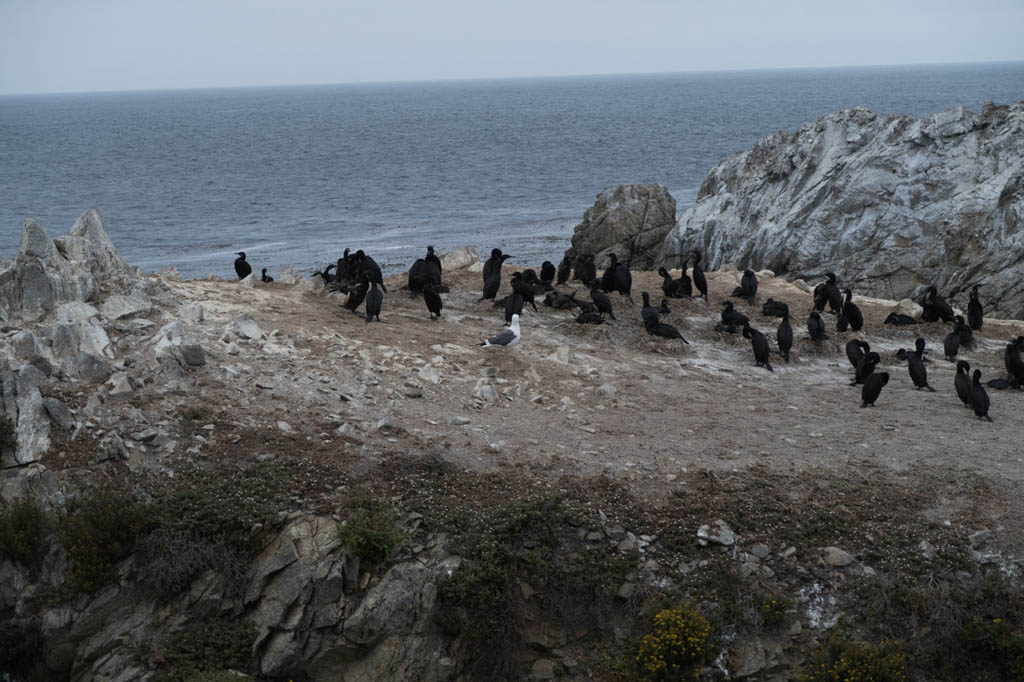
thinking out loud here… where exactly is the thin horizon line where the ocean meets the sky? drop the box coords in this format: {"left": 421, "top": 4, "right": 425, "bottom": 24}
{"left": 0, "top": 58, "right": 1024, "bottom": 98}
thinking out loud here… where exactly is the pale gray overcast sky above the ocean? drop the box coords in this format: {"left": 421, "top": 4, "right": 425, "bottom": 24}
{"left": 0, "top": 0, "right": 1024, "bottom": 93}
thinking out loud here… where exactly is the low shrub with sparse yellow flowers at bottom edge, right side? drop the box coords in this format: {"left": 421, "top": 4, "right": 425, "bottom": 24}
{"left": 797, "top": 635, "right": 906, "bottom": 682}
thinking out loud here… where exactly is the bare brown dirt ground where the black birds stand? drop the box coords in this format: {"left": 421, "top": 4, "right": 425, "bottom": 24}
{"left": 48, "top": 258, "right": 1024, "bottom": 557}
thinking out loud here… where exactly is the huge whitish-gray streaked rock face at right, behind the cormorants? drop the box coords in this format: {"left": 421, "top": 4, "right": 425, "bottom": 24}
{"left": 657, "top": 102, "right": 1024, "bottom": 316}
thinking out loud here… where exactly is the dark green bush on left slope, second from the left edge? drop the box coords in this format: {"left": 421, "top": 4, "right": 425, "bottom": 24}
{"left": 57, "top": 489, "right": 153, "bottom": 594}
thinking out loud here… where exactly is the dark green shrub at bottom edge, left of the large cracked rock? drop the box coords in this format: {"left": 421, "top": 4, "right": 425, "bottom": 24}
{"left": 155, "top": 621, "right": 256, "bottom": 682}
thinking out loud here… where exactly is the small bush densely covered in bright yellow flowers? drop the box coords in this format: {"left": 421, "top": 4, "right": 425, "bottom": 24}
{"left": 636, "top": 606, "right": 711, "bottom": 682}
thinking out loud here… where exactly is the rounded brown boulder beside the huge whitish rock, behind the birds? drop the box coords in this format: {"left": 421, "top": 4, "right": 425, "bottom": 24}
{"left": 565, "top": 184, "right": 676, "bottom": 269}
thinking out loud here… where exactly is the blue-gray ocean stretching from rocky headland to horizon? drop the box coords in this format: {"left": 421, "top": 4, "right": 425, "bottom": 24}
{"left": 0, "top": 62, "right": 1024, "bottom": 278}
